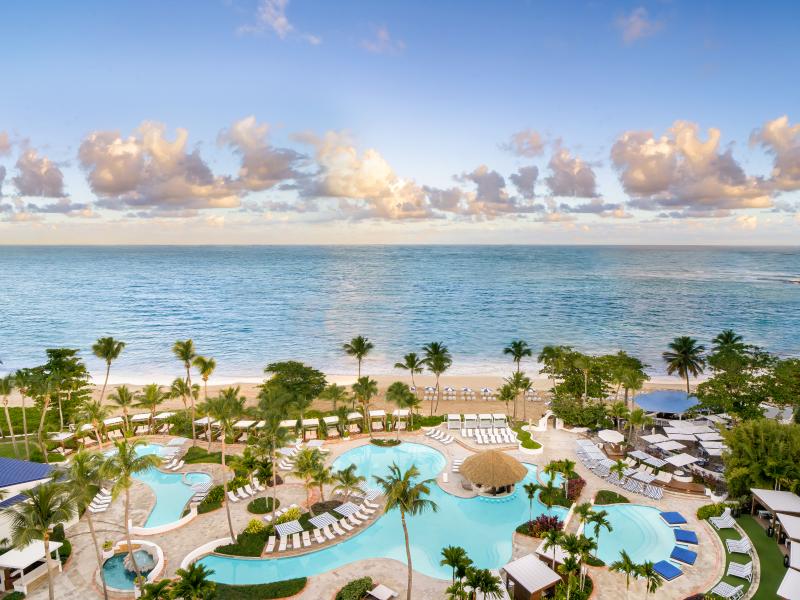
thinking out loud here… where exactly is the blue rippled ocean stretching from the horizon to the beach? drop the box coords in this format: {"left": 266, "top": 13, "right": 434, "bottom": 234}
{"left": 0, "top": 246, "right": 800, "bottom": 382}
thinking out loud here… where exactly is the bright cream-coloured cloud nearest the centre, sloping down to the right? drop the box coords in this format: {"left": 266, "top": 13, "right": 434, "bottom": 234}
{"left": 298, "top": 131, "right": 432, "bottom": 219}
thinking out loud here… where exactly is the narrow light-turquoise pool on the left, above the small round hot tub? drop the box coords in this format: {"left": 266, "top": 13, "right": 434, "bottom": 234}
{"left": 119, "top": 444, "right": 211, "bottom": 528}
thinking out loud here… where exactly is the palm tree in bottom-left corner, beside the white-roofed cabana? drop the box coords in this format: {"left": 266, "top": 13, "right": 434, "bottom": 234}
{"left": 6, "top": 482, "right": 75, "bottom": 600}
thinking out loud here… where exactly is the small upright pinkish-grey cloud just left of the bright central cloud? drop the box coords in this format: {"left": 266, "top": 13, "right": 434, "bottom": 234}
{"left": 218, "top": 116, "right": 307, "bottom": 191}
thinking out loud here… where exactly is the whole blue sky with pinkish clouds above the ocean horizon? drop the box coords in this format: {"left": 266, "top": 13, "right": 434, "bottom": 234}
{"left": 0, "top": 0, "right": 800, "bottom": 245}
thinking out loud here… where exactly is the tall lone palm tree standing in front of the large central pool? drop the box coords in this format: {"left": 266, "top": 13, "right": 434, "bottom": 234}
{"left": 375, "top": 463, "right": 439, "bottom": 600}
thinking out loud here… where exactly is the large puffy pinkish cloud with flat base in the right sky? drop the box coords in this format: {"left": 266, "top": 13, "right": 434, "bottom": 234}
{"left": 611, "top": 121, "right": 772, "bottom": 212}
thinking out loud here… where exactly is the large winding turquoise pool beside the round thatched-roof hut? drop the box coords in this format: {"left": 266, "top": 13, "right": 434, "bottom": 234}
{"left": 199, "top": 443, "right": 567, "bottom": 585}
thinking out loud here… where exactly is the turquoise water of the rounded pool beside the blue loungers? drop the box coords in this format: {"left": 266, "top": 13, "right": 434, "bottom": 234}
{"left": 585, "top": 504, "right": 675, "bottom": 564}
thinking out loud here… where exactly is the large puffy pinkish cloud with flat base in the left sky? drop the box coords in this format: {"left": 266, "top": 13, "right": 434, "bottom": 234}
{"left": 78, "top": 121, "right": 239, "bottom": 210}
